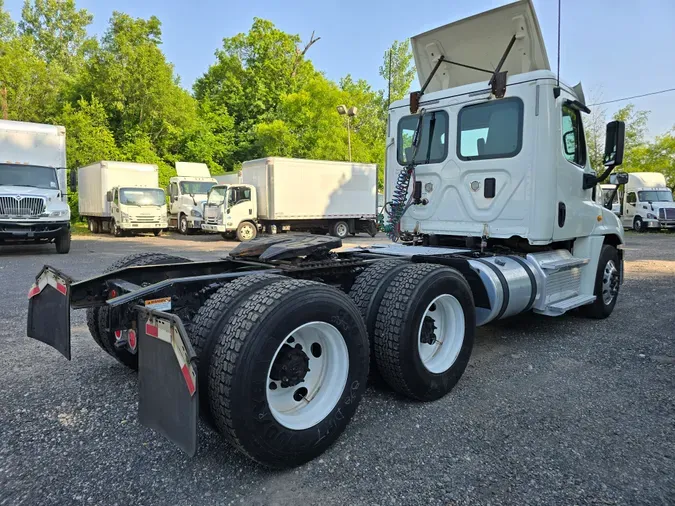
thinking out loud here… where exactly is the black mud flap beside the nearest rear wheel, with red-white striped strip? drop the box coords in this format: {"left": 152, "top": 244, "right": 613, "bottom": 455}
{"left": 137, "top": 306, "right": 199, "bottom": 457}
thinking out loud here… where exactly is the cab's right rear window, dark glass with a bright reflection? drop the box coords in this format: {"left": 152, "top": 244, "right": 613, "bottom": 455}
{"left": 457, "top": 98, "right": 523, "bottom": 160}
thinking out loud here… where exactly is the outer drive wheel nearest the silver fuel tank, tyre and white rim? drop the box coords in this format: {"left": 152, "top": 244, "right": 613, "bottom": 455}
{"left": 374, "top": 264, "right": 476, "bottom": 401}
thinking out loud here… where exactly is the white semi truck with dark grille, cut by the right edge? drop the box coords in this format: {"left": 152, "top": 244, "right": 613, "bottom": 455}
{"left": 621, "top": 172, "right": 675, "bottom": 232}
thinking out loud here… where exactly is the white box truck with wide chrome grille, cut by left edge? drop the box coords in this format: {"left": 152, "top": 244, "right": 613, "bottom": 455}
{"left": 0, "top": 120, "right": 70, "bottom": 253}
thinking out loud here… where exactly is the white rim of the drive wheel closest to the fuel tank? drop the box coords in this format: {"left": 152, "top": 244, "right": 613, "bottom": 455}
{"left": 417, "top": 294, "right": 466, "bottom": 374}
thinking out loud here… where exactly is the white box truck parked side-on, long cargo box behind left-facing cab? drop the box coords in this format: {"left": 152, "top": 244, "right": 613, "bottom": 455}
{"left": 202, "top": 157, "right": 377, "bottom": 241}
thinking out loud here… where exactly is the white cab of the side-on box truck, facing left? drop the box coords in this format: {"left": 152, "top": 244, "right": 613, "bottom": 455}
{"left": 202, "top": 184, "right": 258, "bottom": 241}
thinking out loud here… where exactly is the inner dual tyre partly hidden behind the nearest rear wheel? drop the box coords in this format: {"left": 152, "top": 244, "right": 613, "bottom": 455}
{"left": 190, "top": 274, "right": 288, "bottom": 427}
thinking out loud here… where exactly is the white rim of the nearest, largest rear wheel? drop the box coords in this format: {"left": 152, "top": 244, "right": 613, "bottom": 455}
{"left": 266, "top": 321, "right": 349, "bottom": 430}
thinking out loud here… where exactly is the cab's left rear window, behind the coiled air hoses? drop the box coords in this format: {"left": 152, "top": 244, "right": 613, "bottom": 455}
{"left": 396, "top": 111, "right": 448, "bottom": 165}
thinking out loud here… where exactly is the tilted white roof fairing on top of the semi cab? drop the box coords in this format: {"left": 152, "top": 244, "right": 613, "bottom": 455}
{"left": 411, "top": 0, "right": 550, "bottom": 92}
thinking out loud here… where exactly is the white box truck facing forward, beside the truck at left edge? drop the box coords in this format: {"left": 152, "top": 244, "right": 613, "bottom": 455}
{"left": 77, "top": 161, "right": 168, "bottom": 237}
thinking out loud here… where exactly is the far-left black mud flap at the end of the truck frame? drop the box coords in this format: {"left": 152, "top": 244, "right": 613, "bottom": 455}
{"left": 26, "top": 265, "right": 73, "bottom": 360}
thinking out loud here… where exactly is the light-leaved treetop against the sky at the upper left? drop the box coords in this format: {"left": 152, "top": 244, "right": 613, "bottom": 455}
{"left": 19, "top": 0, "right": 94, "bottom": 73}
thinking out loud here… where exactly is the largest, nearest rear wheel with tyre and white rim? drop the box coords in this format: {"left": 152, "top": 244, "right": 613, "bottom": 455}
{"left": 209, "top": 279, "right": 368, "bottom": 468}
